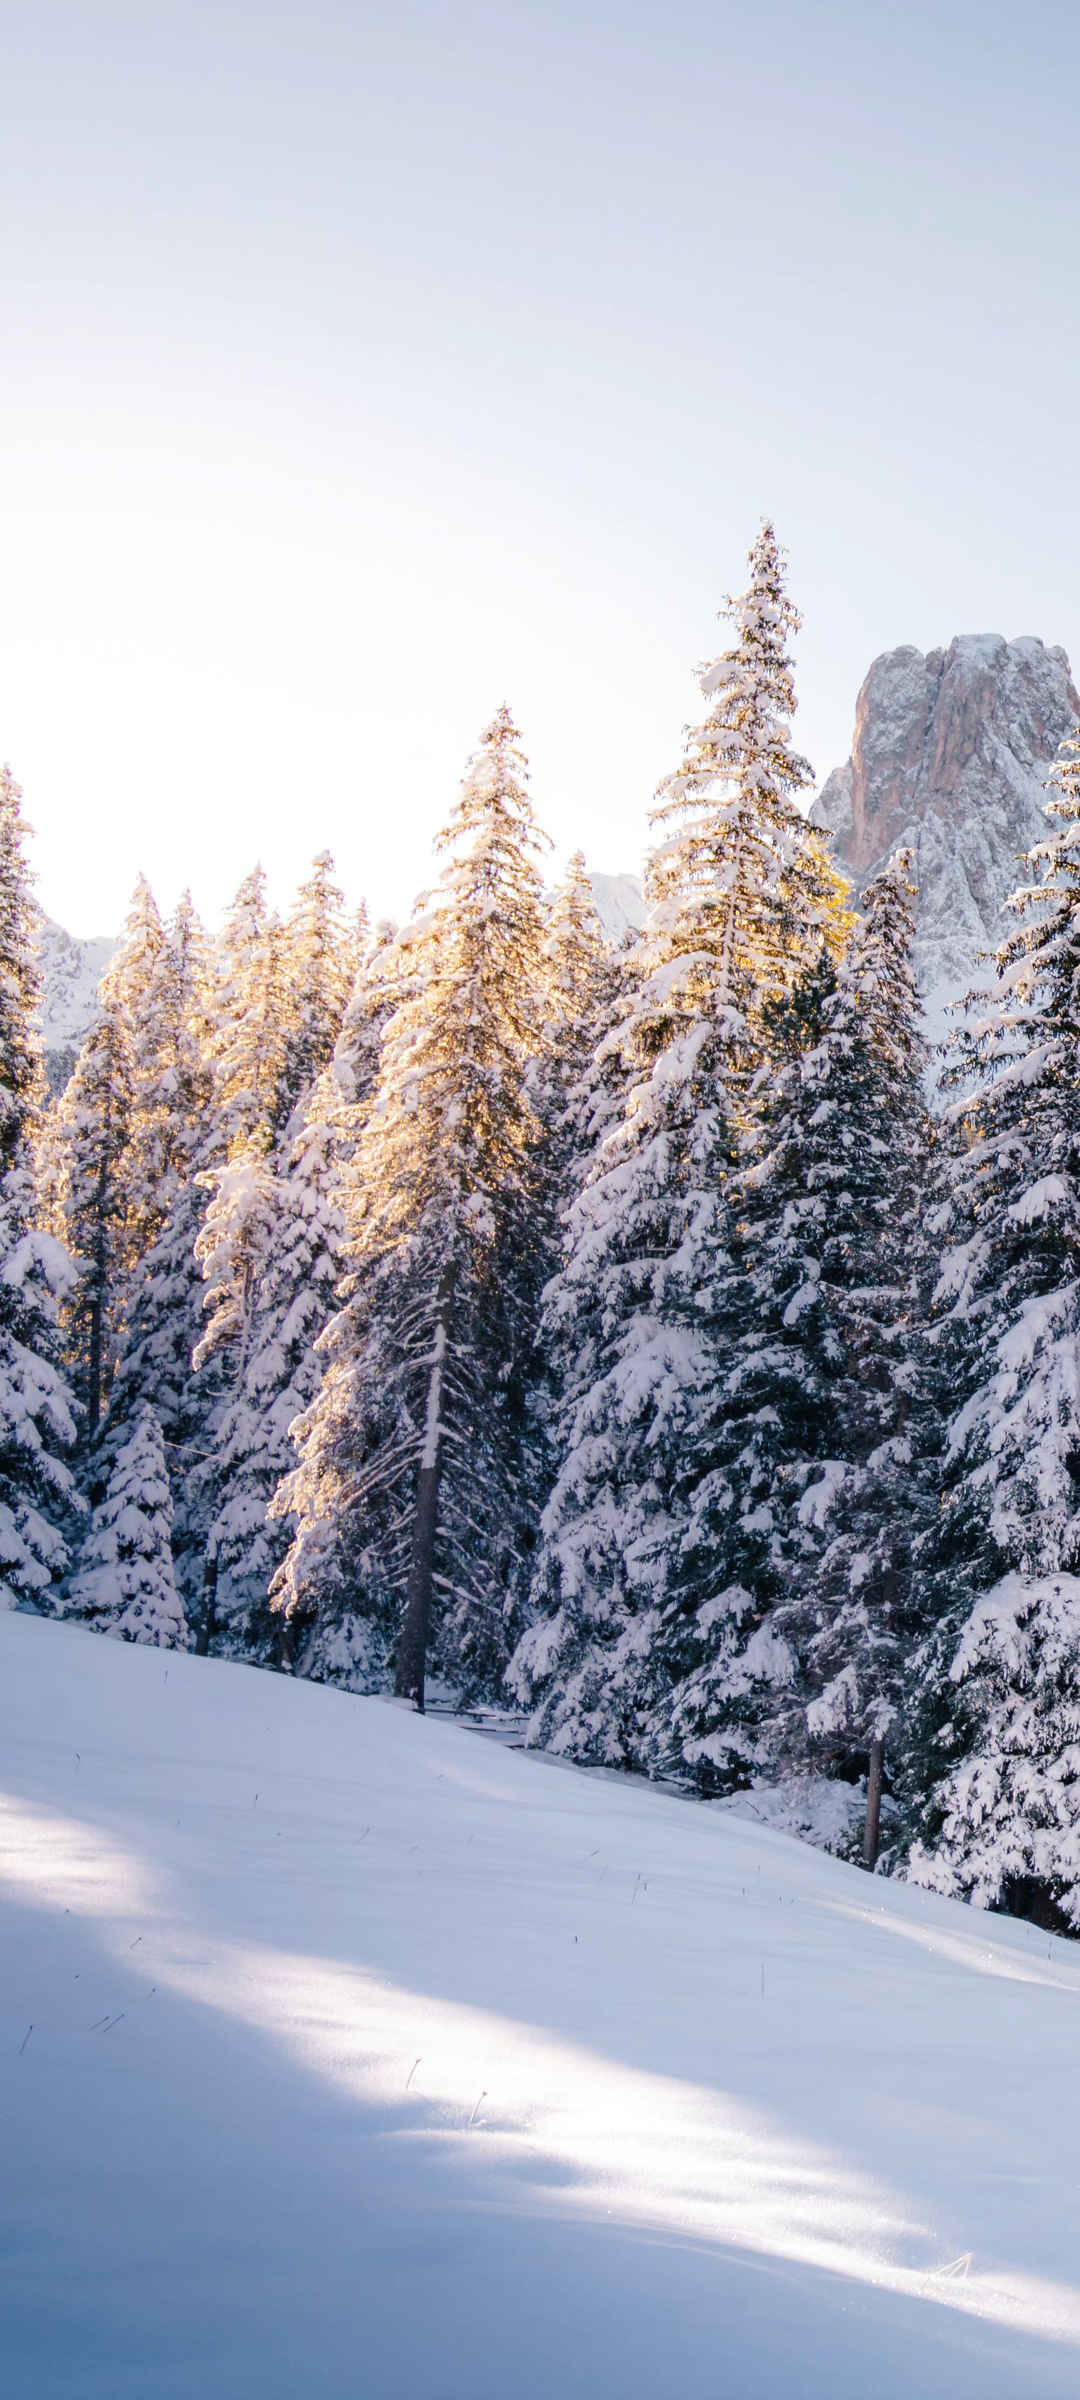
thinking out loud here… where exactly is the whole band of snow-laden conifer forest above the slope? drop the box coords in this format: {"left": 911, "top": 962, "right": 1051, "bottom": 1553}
{"left": 0, "top": 523, "right": 1080, "bottom": 1932}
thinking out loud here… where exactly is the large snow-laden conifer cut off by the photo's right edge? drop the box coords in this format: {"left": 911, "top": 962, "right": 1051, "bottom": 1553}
{"left": 907, "top": 734, "right": 1080, "bottom": 1930}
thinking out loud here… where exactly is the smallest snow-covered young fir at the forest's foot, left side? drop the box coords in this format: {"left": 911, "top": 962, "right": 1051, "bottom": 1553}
{"left": 67, "top": 1406, "right": 187, "bottom": 1649}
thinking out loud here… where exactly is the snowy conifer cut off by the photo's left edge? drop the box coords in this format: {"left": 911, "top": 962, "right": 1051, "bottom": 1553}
{"left": 0, "top": 766, "right": 79, "bottom": 1608}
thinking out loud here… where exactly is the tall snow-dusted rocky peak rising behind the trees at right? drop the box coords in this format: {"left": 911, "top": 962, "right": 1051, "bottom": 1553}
{"left": 814, "top": 634, "right": 1080, "bottom": 1030}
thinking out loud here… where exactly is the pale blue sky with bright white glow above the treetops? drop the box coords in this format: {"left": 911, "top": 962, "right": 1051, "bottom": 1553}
{"left": 0, "top": 0, "right": 1080, "bottom": 934}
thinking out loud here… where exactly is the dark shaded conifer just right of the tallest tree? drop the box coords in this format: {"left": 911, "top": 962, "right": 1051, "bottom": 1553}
{"left": 674, "top": 854, "right": 929, "bottom": 1833}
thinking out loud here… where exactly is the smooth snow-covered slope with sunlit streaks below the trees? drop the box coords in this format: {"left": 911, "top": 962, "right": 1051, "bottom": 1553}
{"left": 0, "top": 1615, "right": 1080, "bottom": 2400}
